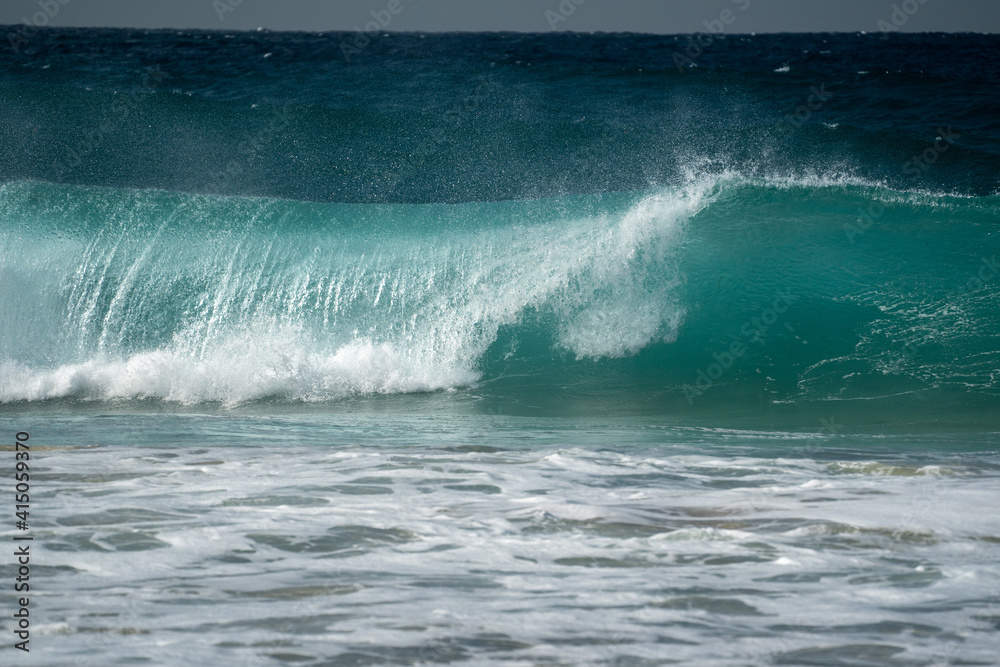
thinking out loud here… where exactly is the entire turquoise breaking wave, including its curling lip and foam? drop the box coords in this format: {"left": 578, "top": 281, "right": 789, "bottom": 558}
{"left": 0, "top": 176, "right": 1000, "bottom": 420}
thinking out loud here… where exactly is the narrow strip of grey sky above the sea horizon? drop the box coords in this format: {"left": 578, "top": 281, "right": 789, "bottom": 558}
{"left": 0, "top": 0, "right": 1000, "bottom": 34}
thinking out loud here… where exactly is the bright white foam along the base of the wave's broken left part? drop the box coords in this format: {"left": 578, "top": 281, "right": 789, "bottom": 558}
{"left": 0, "top": 332, "right": 475, "bottom": 405}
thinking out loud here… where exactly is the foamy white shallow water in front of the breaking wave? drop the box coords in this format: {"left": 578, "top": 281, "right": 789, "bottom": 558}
{"left": 0, "top": 410, "right": 1000, "bottom": 665}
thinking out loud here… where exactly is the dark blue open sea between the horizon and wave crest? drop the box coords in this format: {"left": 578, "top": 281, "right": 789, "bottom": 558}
{"left": 0, "top": 30, "right": 1000, "bottom": 203}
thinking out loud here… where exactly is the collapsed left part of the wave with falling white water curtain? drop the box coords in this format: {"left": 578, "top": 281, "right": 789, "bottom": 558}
{"left": 0, "top": 184, "right": 703, "bottom": 403}
